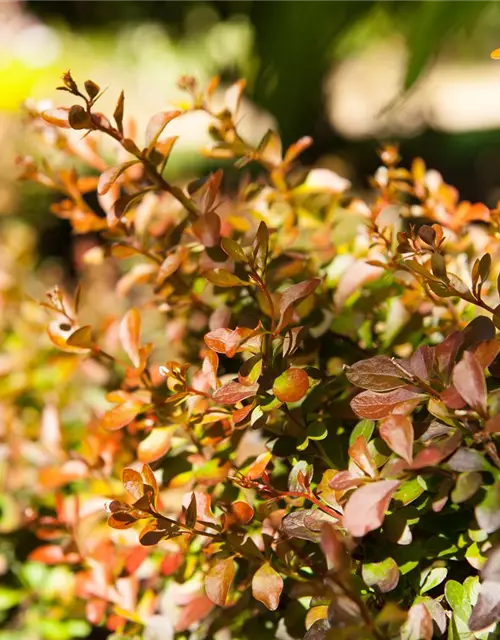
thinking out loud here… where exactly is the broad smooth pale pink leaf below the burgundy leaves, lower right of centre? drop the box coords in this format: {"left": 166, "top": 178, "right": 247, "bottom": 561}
{"left": 344, "top": 480, "right": 400, "bottom": 538}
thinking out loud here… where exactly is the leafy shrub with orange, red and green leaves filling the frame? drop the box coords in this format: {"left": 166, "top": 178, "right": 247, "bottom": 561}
{"left": 10, "top": 73, "right": 500, "bottom": 640}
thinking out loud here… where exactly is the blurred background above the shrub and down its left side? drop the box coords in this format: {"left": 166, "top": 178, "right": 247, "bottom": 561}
{"left": 0, "top": 0, "right": 500, "bottom": 640}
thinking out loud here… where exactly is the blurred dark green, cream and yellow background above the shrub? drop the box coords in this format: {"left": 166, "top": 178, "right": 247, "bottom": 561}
{"left": 4, "top": 0, "right": 500, "bottom": 226}
